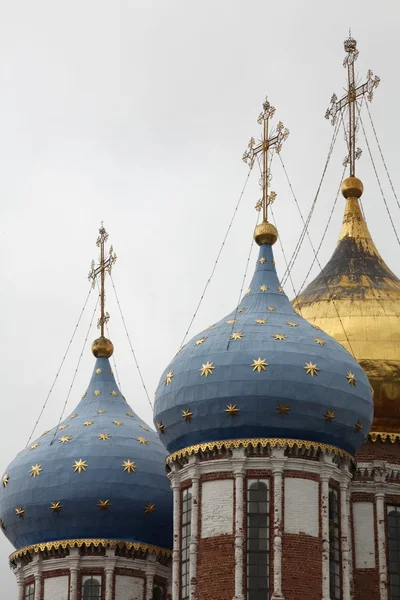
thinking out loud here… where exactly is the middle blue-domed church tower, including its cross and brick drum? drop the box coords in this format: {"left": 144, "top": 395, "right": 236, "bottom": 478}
{"left": 154, "top": 100, "right": 373, "bottom": 600}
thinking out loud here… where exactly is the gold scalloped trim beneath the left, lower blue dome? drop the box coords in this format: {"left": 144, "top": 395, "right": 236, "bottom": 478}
{"left": 9, "top": 538, "right": 172, "bottom": 560}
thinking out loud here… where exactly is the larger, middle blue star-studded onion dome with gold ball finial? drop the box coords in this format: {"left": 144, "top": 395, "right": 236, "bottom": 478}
{"left": 154, "top": 227, "right": 373, "bottom": 454}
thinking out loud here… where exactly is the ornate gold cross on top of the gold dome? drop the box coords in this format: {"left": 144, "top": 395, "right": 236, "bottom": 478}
{"left": 325, "top": 35, "right": 380, "bottom": 177}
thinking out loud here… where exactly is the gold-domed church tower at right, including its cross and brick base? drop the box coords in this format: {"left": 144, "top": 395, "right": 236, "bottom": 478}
{"left": 294, "top": 38, "right": 400, "bottom": 600}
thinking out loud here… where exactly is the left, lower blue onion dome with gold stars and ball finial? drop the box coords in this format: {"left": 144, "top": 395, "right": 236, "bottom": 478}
{"left": 0, "top": 340, "right": 172, "bottom": 549}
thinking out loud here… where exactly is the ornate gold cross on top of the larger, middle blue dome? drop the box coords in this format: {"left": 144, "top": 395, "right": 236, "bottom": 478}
{"left": 243, "top": 98, "right": 289, "bottom": 221}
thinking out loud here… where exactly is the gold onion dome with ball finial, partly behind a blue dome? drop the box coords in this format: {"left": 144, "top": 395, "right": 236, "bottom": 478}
{"left": 293, "top": 177, "right": 400, "bottom": 433}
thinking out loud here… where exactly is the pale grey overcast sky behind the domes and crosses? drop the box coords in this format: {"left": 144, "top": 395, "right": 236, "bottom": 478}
{"left": 0, "top": 0, "right": 400, "bottom": 600}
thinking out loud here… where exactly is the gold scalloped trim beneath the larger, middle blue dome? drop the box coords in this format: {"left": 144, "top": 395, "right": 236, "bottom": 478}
{"left": 165, "top": 438, "right": 354, "bottom": 464}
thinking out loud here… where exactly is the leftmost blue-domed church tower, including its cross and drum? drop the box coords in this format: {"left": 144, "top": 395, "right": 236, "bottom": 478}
{"left": 0, "top": 226, "right": 172, "bottom": 600}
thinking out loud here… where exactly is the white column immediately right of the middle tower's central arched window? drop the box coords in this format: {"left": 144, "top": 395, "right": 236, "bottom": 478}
{"left": 271, "top": 448, "right": 286, "bottom": 600}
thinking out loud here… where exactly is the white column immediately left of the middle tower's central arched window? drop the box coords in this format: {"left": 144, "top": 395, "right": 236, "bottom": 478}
{"left": 232, "top": 448, "right": 245, "bottom": 600}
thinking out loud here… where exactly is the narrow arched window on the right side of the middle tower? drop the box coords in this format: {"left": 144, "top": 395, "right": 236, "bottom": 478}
{"left": 329, "top": 487, "right": 342, "bottom": 600}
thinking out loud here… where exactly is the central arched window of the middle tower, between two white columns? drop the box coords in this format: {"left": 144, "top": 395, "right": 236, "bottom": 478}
{"left": 247, "top": 479, "right": 269, "bottom": 600}
